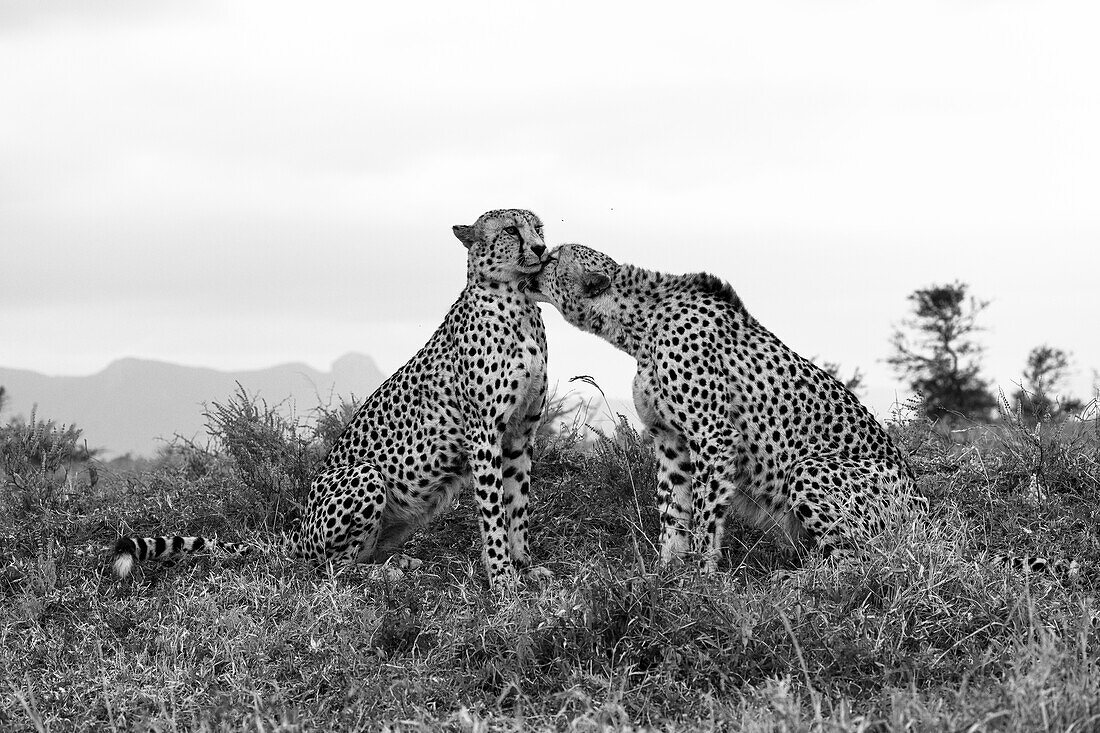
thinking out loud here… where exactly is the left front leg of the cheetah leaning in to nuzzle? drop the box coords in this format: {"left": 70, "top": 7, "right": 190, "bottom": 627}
{"left": 650, "top": 428, "right": 693, "bottom": 565}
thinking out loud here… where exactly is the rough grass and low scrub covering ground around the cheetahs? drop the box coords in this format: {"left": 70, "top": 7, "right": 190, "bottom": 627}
{"left": 0, "top": 393, "right": 1100, "bottom": 731}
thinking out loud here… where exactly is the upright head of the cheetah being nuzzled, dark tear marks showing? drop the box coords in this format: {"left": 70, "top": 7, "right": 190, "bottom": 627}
{"left": 452, "top": 209, "right": 550, "bottom": 283}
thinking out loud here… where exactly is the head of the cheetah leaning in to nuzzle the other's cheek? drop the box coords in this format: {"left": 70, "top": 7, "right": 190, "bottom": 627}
{"left": 526, "top": 244, "right": 620, "bottom": 336}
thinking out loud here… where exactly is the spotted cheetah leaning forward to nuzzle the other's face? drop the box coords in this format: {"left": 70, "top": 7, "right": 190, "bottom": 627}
{"left": 526, "top": 244, "right": 1073, "bottom": 572}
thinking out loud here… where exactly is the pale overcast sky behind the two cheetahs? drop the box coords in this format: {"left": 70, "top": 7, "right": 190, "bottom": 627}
{"left": 0, "top": 0, "right": 1100, "bottom": 412}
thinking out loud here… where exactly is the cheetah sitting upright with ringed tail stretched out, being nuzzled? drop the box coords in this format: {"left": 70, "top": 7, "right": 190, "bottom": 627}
{"left": 113, "top": 209, "right": 549, "bottom": 586}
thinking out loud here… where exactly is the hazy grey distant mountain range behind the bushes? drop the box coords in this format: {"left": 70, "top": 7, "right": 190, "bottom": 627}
{"left": 0, "top": 353, "right": 384, "bottom": 457}
